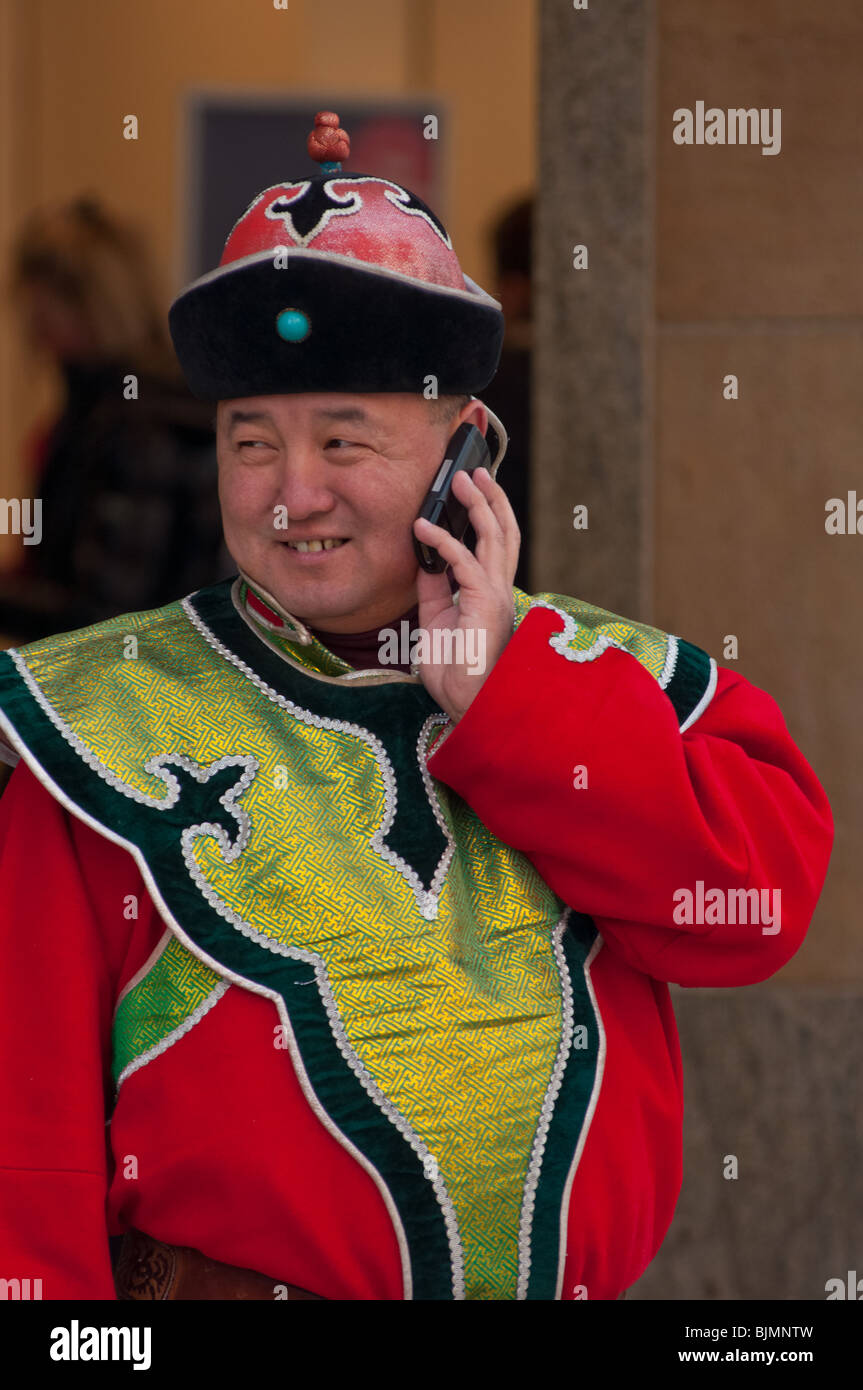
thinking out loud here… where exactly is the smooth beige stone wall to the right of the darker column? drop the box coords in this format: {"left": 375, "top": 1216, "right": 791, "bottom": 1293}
{"left": 653, "top": 0, "right": 863, "bottom": 984}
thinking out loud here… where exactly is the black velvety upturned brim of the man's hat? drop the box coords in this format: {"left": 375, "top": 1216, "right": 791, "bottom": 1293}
{"left": 168, "top": 249, "right": 504, "bottom": 402}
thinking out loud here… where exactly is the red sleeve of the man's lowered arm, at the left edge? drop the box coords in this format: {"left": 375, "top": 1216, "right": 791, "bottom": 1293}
{"left": 0, "top": 762, "right": 159, "bottom": 1300}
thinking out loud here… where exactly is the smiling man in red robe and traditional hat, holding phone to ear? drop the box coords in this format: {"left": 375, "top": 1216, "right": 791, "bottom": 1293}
{"left": 0, "top": 114, "right": 832, "bottom": 1300}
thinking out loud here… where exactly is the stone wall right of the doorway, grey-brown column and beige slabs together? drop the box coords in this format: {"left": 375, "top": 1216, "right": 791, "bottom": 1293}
{"left": 532, "top": 0, "right": 863, "bottom": 987}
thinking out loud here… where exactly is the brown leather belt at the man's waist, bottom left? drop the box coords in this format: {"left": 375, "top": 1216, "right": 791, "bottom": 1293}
{"left": 114, "top": 1230, "right": 325, "bottom": 1302}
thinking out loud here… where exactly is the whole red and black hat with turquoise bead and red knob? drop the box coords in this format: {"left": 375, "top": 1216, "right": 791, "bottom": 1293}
{"left": 168, "top": 111, "right": 504, "bottom": 400}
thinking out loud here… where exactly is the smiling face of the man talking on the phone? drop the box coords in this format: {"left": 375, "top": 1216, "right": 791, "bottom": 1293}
{"left": 217, "top": 392, "right": 488, "bottom": 632}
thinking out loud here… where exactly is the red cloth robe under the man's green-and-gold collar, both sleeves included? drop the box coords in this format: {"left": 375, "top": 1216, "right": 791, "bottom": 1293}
{"left": 0, "top": 609, "right": 832, "bottom": 1300}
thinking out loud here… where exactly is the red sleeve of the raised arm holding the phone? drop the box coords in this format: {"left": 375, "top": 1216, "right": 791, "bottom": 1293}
{"left": 428, "top": 609, "right": 832, "bottom": 986}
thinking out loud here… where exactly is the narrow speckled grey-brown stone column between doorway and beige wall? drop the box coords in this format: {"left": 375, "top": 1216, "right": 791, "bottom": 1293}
{"left": 531, "top": 0, "right": 655, "bottom": 620}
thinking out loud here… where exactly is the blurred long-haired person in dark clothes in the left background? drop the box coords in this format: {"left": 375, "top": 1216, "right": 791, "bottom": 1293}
{"left": 0, "top": 197, "right": 233, "bottom": 642}
